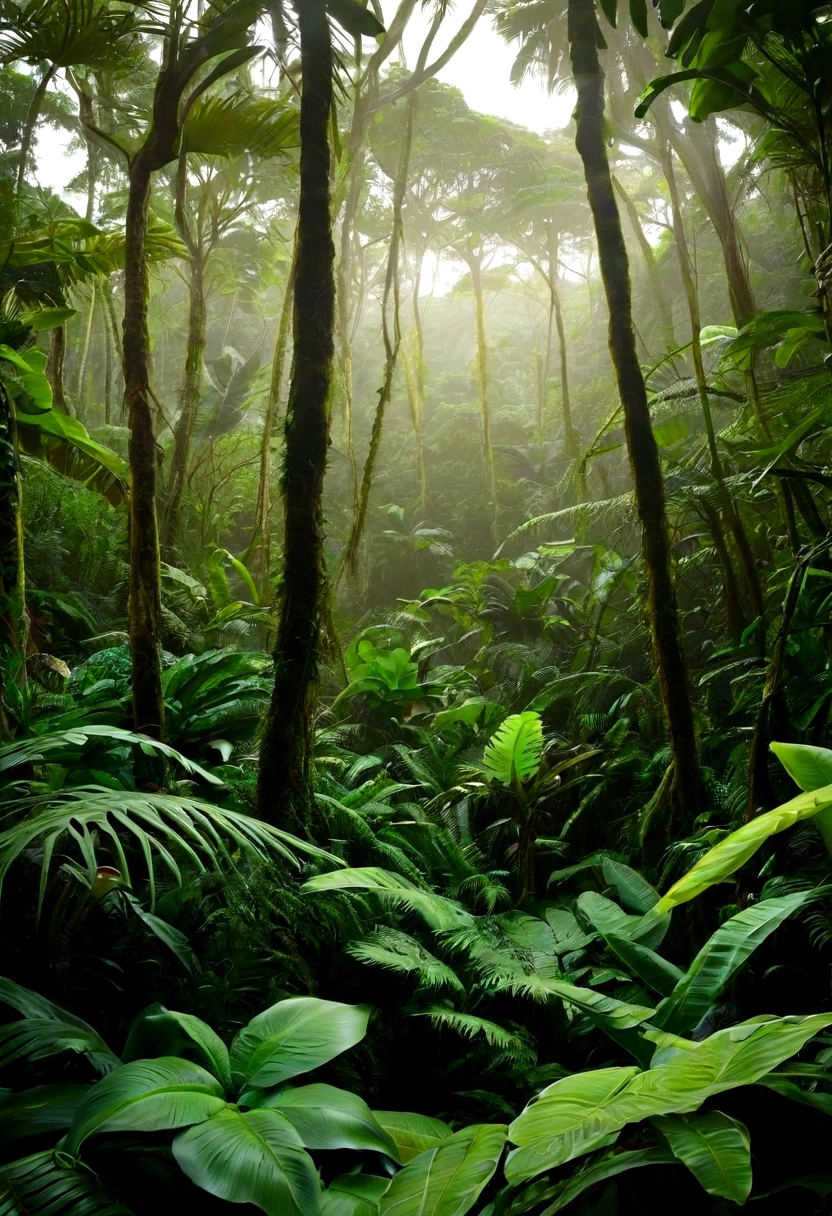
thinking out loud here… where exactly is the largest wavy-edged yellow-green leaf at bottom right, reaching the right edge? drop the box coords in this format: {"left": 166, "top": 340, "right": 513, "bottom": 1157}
{"left": 506, "top": 1014, "right": 832, "bottom": 1183}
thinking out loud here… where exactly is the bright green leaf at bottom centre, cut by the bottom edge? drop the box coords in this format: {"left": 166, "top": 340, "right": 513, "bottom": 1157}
{"left": 378, "top": 1124, "right": 506, "bottom": 1216}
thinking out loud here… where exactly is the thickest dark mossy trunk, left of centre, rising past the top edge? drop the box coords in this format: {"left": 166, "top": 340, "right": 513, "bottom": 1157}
{"left": 258, "top": 0, "right": 335, "bottom": 828}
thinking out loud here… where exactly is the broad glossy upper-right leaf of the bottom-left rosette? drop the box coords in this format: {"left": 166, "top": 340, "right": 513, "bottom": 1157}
{"left": 231, "top": 996, "right": 370, "bottom": 1086}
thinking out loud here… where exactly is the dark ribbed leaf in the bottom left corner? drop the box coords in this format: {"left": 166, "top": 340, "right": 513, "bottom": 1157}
{"left": 0, "top": 1153, "right": 134, "bottom": 1216}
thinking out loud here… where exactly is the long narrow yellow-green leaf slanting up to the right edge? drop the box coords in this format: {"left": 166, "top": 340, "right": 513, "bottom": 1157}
{"left": 651, "top": 784, "right": 832, "bottom": 916}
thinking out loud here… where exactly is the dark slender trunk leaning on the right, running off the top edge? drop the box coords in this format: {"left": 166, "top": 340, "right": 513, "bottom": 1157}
{"left": 568, "top": 0, "right": 702, "bottom": 828}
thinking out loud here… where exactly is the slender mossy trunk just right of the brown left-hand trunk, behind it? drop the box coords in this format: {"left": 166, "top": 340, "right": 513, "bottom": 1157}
{"left": 162, "top": 250, "right": 207, "bottom": 557}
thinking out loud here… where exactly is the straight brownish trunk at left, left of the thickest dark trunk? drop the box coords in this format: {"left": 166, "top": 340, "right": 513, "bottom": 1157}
{"left": 123, "top": 148, "right": 164, "bottom": 738}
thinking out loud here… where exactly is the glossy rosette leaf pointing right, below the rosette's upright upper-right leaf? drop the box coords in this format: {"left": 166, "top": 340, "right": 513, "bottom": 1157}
{"left": 248, "top": 1085, "right": 399, "bottom": 1161}
